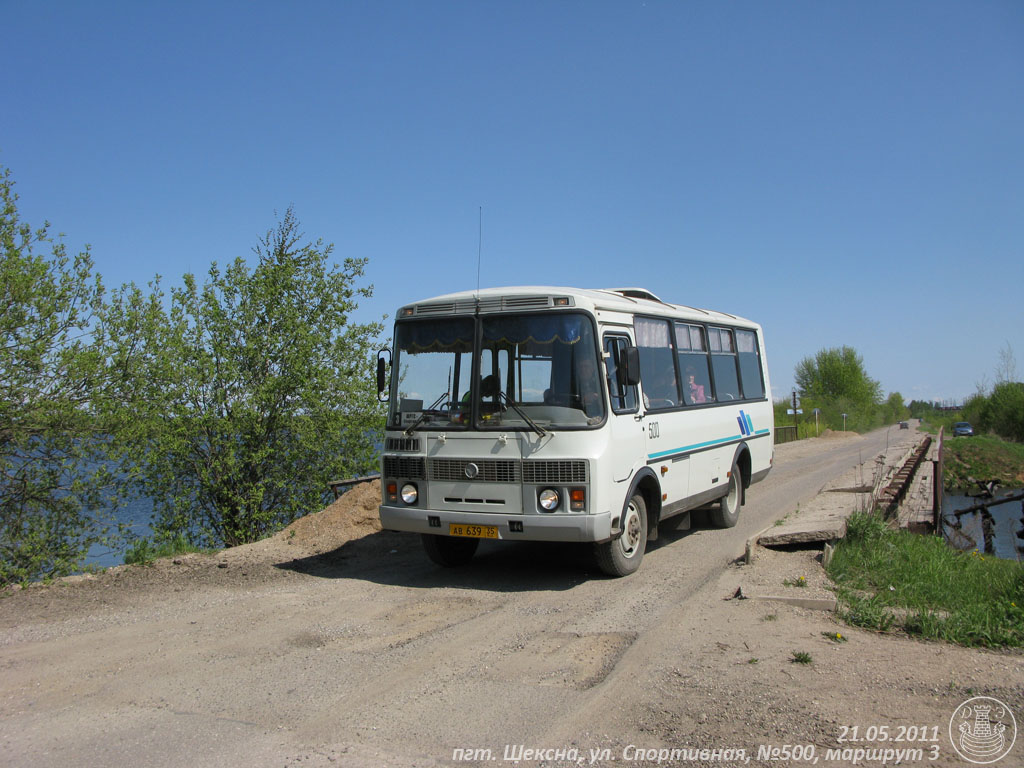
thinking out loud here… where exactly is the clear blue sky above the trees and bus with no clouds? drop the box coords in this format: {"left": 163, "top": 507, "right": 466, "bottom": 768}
{"left": 0, "top": 0, "right": 1024, "bottom": 400}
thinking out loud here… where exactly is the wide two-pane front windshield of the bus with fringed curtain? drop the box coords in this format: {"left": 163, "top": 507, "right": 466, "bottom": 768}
{"left": 389, "top": 312, "right": 605, "bottom": 429}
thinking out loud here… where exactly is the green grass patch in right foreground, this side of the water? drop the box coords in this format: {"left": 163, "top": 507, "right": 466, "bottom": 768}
{"left": 828, "top": 513, "right": 1024, "bottom": 647}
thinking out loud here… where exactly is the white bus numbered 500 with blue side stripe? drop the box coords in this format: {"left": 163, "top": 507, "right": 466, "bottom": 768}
{"left": 377, "top": 287, "right": 774, "bottom": 575}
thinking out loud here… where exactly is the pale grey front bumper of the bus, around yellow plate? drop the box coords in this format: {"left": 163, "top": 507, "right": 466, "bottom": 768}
{"left": 380, "top": 504, "right": 612, "bottom": 542}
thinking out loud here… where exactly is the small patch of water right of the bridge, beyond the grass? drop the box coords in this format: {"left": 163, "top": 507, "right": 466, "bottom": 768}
{"left": 942, "top": 488, "right": 1024, "bottom": 560}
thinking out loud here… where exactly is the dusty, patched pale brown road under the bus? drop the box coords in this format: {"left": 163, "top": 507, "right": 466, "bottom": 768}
{"left": 0, "top": 430, "right": 1024, "bottom": 768}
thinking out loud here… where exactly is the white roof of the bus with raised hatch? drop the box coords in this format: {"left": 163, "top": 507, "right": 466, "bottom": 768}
{"left": 397, "top": 286, "right": 758, "bottom": 328}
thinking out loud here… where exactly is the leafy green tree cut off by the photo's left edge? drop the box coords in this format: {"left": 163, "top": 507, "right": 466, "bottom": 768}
{"left": 0, "top": 163, "right": 121, "bottom": 585}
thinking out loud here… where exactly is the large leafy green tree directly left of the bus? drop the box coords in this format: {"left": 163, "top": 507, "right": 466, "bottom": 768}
{"left": 119, "top": 209, "right": 383, "bottom": 546}
